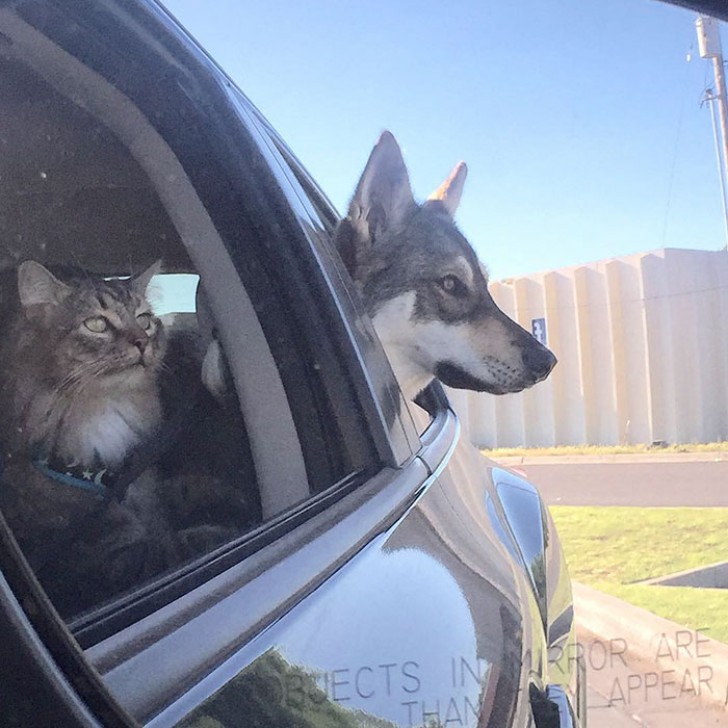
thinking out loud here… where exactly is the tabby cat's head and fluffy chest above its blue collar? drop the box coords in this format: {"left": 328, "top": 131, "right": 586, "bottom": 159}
{"left": 0, "top": 261, "right": 165, "bottom": 468}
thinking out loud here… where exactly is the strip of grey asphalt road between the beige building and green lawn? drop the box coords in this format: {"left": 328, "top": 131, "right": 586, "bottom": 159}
{"left": 515, "top": 460, "right": 728, "bottom": 507}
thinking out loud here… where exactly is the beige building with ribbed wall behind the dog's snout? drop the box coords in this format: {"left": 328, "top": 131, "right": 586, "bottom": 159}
{"left": 451, "top": 249, "right": 728, "bottom": 447}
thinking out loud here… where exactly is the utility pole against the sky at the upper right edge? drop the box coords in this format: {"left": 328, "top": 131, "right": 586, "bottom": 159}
{"left": 695, "top": 15, "right": 728, "bottom": 250}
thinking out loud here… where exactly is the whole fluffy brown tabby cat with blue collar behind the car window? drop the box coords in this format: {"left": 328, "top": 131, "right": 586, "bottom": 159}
{"left": 0, "top": 261, "right": 174, "bottom": 613}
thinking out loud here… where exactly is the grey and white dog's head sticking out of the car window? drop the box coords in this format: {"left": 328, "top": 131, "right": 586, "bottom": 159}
{"left": 334, "top": 132, "right": 556, "bottom": 400}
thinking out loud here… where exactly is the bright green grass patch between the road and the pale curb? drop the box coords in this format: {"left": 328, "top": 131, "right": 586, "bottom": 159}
{"left": 550, "top": 506, "right": 728, "bottom": 643}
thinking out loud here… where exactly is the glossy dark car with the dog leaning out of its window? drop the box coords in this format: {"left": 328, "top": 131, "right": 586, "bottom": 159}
{"left": 0, "top": 0, "right": 586, "bottom": 728}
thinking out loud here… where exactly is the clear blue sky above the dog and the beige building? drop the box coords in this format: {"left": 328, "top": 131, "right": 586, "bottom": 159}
{"left": 165, "top": 0, "right": 728, "bottom": 279}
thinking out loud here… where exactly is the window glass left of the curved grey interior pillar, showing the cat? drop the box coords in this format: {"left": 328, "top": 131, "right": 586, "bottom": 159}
{"left": 0, "top": 63, "right": 263, "bottom": 617}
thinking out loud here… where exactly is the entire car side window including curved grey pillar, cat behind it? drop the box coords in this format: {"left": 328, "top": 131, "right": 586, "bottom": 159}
{"left": 0, "top": 16, "right": 383, "bottom": 633}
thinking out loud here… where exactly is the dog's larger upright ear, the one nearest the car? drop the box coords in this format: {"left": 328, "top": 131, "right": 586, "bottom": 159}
{"left": 336, "top": 131, "right": 415, "bottom": 279}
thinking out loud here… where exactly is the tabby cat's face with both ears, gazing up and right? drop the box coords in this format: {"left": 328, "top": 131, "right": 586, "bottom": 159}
{"left": 18, "top": 261, "right": 165, "bottom": 386}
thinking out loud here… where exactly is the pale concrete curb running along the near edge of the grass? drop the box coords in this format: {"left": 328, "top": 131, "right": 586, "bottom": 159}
{"left": 572, "top": 582, "right": 728, "bottom": 710}
